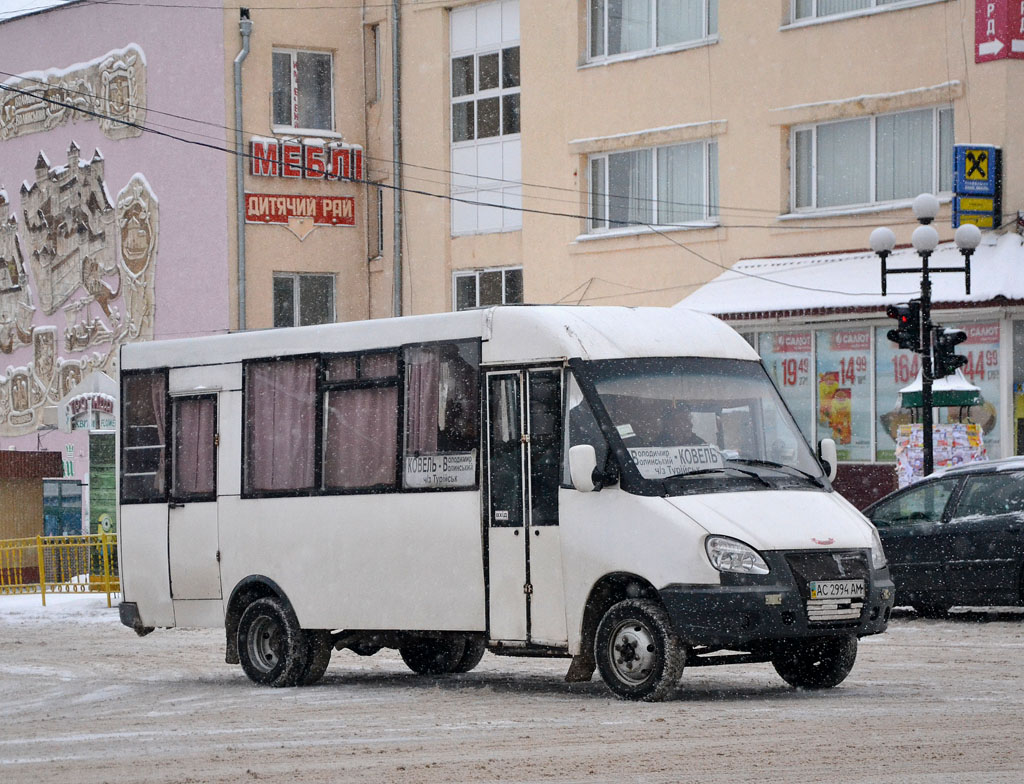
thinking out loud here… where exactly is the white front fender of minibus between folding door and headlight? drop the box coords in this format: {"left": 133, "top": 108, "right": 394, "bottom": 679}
{"left": 558, "top": 488, "right": 721, "bottom": 654}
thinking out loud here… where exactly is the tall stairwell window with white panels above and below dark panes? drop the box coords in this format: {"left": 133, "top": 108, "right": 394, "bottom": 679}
{"left": 451, "top": 0, "right": 522, "bottom": 234}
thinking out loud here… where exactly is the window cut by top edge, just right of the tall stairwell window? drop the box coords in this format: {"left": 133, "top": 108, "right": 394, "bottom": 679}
{"left": 590, "top": 0, "right": 718, "bottom": 59}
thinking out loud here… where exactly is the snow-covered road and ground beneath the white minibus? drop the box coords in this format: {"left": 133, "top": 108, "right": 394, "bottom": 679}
{"left": 0, "top": 595, "right": 1024, "bottom": 784}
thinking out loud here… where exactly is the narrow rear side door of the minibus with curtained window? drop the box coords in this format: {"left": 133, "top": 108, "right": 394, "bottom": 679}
{"left": 167, "top": 394, "right": 221, "bottom": 600}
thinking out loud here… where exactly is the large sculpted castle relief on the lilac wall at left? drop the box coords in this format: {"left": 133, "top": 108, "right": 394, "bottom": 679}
{"left": 0, "top": 145, "right": 160, "bottom": 436}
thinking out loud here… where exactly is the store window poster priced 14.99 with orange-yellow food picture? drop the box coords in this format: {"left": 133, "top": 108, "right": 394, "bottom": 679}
{"left": 815, "top": 329, "right": 872, "bottom": 461}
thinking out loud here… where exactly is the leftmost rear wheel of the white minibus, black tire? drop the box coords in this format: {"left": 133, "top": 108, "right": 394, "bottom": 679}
{"left": 236, "top": 597, "right": 308, "bottom": 686}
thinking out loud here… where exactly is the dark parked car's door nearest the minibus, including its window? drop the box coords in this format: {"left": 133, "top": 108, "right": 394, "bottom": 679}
{"left": 868, "top": 477, "right": 961, "bottom": 603}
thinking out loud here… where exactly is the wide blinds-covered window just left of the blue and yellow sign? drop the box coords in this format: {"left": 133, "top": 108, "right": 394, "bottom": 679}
{"left": 791, "top": 106, "right": 953, "bottom": 210}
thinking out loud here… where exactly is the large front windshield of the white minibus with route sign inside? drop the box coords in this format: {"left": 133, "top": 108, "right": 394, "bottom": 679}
{"left": 586, "top": 357, "right": 824, "bottom": 487}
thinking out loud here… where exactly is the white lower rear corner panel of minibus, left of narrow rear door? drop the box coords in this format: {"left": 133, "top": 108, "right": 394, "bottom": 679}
{"left": 118, "top": 504, "right": 174, "bottom": 626}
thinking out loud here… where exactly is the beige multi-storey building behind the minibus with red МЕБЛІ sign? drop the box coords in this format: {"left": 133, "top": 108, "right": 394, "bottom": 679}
{"left": 225, "top": 0, "right": 1024, "bottom": 503}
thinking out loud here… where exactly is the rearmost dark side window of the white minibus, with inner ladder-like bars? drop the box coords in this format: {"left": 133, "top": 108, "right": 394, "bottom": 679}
{"left": 121, "top": 371, "right": 167, "bottom": 503}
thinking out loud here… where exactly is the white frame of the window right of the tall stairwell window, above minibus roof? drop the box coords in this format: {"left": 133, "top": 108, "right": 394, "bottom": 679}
{"left": 587, "top": 139, "right": 720, "bottom": 234}
